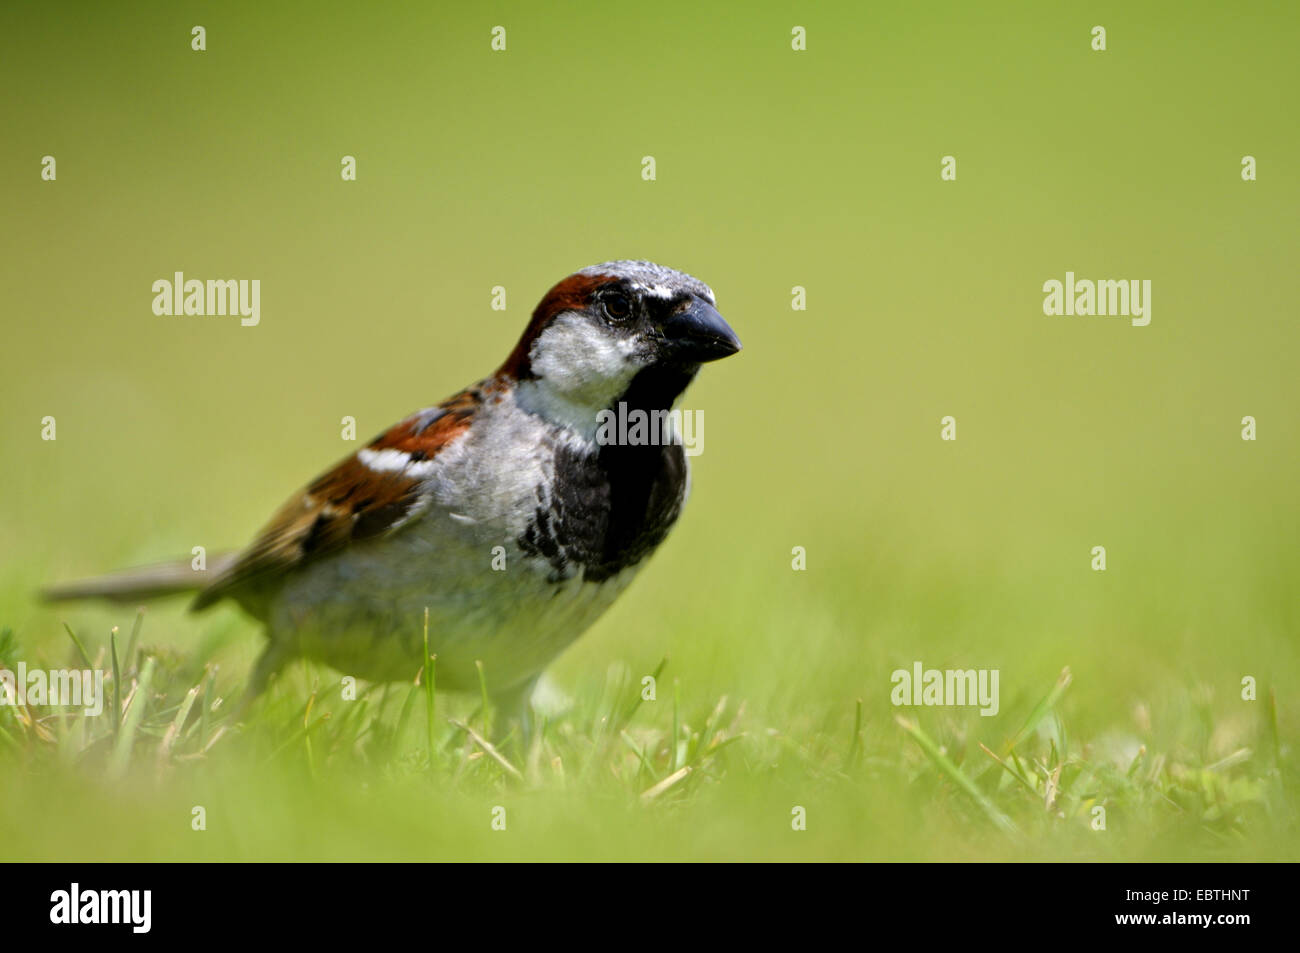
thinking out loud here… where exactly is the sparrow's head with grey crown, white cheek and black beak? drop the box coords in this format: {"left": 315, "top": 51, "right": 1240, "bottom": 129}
{"left": 498, "top": 261, "right": 741, "bottom": 426}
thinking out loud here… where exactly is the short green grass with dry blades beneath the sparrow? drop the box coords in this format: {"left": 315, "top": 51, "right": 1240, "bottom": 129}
{"left": 0, "top": 587, "right": 1300, "bottom": 859}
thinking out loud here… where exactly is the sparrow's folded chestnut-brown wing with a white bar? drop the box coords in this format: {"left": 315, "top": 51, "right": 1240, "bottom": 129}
{"left": 191, "top": 387, "right": 482, "bottom": 610}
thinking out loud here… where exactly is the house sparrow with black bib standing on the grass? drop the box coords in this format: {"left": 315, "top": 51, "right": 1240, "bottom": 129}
{"left": 46, "top": 261, "right": 741, "bottom": 711}
